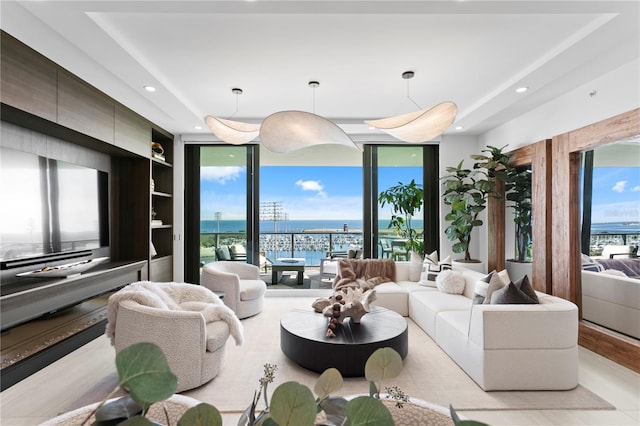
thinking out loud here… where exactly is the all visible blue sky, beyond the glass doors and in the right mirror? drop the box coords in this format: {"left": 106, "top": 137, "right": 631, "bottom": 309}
{"left": 201, "top": 166, "right": 640, "bottom": 223}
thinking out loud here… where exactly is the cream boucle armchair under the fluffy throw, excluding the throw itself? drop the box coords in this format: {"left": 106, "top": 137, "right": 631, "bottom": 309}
{"left": 114, "top": 300, "right": 230, "bottom": 392}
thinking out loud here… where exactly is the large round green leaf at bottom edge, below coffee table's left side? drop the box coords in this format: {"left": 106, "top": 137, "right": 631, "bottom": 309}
{"left": 269, "top": 382, "right": 317, "bottom": 426}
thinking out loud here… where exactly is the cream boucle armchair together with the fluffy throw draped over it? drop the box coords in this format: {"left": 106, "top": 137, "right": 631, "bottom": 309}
{"left": 106, "top": 281, "right": 243, "bottom": 392}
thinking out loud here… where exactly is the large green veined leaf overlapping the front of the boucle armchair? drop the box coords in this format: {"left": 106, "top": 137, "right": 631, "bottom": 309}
{"left": 116, "top": 342, "right": 178, "bottom": 407}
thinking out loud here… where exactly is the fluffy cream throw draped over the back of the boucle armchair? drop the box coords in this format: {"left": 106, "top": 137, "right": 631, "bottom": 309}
{"left": 105, "top": 281, "right": 244, "bottom": 346}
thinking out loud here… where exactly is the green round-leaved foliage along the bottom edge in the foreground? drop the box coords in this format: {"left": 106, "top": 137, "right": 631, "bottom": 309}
{"left": 82, "top": 343, "right": 483, "bottom": 426}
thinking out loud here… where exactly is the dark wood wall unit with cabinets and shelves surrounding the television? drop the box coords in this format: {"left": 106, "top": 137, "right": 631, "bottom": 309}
{"left": 0, "top": 30, "right": 173, "bottom": 388}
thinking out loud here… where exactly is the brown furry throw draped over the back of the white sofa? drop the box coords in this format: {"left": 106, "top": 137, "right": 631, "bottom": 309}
{"left": 333, "top": 259, "right": 396, "bottom": 290}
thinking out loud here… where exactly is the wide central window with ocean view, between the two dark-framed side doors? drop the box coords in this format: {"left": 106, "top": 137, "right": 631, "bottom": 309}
{"left": 259, "top": 145, "right": 363, "bottom": 266}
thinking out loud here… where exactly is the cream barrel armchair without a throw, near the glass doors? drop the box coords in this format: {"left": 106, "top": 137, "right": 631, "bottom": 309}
{"left": 200, "top": 261, "right": 267, "bottom": 318}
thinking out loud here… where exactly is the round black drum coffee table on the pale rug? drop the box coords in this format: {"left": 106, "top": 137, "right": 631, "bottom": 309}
{"left": 280, "top": 307, "right": 409, "bottom": 377}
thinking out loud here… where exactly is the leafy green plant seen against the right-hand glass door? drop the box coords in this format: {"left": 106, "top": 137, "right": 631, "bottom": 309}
{"left": 378, "top": 179, "right": 424, "bottom": 256}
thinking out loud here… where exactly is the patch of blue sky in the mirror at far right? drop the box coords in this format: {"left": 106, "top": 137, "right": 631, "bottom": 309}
{"left": 591, "top": 167, "right": 640, "bottom": 223}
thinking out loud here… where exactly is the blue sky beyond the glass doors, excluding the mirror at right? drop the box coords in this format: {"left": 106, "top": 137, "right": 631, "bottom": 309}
{"left": 201, "top": 166, "right": 421, "bottom": 220}
